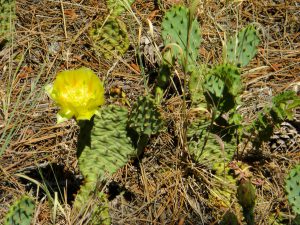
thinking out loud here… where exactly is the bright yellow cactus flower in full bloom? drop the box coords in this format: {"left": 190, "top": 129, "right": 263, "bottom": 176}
{"left": 46, "top": 67, "right": 105, "bottom": 123}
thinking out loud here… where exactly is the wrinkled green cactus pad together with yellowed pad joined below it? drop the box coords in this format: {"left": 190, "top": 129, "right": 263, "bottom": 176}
{"left": 187, "top": 121, "right": 235, "bottom": 207}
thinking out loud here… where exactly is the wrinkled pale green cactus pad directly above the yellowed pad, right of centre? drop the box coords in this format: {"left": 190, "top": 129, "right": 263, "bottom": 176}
{"left": 187, "top": 122, "right": 235, "bottom": 170}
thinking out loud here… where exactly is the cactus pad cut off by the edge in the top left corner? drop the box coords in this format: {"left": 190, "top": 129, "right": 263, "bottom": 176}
{"left": 0, "top": 0, "right": 16, "bottom": 42}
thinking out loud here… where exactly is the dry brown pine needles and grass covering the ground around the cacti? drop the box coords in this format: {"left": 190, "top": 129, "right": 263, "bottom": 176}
{"left": 0, "top": 0, "right": 300, "bottom": 225}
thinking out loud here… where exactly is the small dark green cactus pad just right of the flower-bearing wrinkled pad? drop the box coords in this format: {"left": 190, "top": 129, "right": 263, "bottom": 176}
{"left": 128, "top": 95, "right": 163, "bottom": 136}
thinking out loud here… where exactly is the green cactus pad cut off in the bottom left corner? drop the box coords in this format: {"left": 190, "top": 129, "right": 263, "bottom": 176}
{"left": 4, "top": 196, "right": 35, "bottom": 225}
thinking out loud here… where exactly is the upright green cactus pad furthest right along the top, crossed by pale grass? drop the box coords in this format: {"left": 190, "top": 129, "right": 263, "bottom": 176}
{"left": 225, "top": 25, "right": 260, "bottom": 67}
